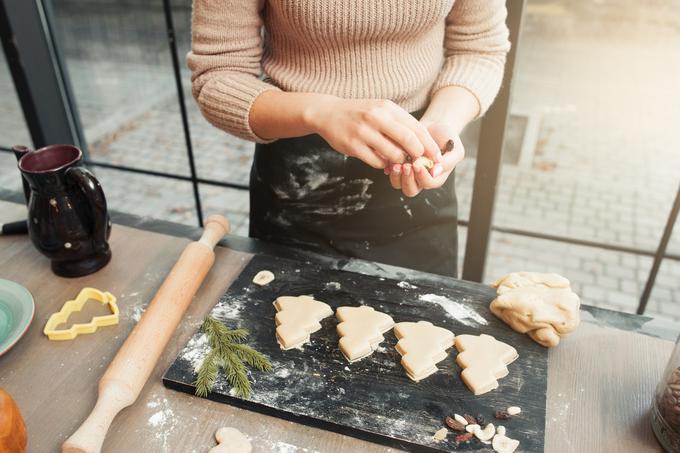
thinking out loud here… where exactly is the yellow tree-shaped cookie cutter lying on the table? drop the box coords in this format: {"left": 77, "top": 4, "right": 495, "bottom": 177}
{"left": 43, "top": 288, "right": 118, "bottom": 340}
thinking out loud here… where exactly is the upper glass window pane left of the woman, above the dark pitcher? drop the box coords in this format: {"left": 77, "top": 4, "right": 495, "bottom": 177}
{"left": 54, "top": 0, "right": 189, "bottom": 175}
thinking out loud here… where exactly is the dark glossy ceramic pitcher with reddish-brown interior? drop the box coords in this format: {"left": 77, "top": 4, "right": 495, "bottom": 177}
{"left": 19, "top": 145, "right": 111, "bottom": 277}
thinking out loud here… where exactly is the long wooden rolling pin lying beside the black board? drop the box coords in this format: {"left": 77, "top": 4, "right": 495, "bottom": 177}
{"left": 61, "top": 216, "right": 229, "bottom": 453}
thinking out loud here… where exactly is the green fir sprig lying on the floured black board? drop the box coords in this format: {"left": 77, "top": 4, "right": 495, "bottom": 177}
{"left": 196, "top": 316, "right": 272, "bottom": 398}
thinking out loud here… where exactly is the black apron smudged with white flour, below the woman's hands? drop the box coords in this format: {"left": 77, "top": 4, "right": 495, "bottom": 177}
{"left": 250, "top": 113, "right": 458, "bottom": 277}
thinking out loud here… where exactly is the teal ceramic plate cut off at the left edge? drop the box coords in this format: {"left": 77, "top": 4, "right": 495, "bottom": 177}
{"left": 0, "top": 278, "right": 35, "bottom": 355}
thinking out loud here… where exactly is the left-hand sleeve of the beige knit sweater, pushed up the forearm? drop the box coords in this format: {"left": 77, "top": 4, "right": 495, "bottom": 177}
{"left": 187, "top": 0, "right": 278, "bottom": 143}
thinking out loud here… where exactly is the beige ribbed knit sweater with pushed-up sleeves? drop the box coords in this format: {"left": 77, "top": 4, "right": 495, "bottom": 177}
{"left": 188, "top": 0, "right": 510, "bottom": 142}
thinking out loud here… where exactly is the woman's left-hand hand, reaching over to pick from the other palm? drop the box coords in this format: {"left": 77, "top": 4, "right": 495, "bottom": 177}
{"left": 304, "top": 96, "right": 442, "bottom": 169}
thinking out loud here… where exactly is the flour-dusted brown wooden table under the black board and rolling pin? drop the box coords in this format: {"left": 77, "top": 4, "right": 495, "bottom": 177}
{"left": 0, "top": 199, "right": 668, "bottom": 453}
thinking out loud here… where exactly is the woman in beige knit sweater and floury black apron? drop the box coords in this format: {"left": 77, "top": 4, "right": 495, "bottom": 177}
{"left": 188, "top": 0, "right": 509, "bottom": 276}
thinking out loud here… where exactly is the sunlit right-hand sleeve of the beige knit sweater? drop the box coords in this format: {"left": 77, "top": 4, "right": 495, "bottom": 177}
{"left": 432, "top": 0, "right": 510, "bottom": 116}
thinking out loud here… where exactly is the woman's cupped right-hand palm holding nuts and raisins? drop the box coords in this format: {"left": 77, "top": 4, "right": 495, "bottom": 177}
{"left": 385, "top": 123, "right": 465, "bottom": 197}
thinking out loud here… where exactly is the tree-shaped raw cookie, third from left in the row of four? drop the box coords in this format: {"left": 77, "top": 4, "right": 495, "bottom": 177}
{"left": 394, "top": 321, "right": 454, "bottom": 382}
